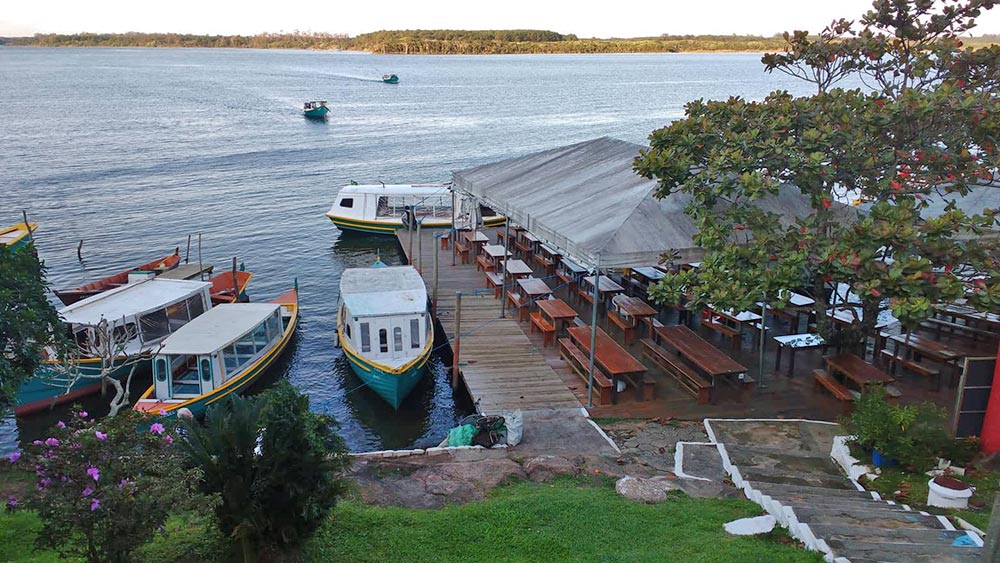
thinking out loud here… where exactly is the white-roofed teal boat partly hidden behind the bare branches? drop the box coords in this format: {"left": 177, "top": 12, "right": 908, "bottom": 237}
{"left": 14, "top": 278, "right": 212, "bottom": 416}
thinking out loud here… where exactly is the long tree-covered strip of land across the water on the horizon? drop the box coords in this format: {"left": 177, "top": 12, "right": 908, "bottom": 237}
{"left": 0, "top": 30, "right": 812, "bottom": 55}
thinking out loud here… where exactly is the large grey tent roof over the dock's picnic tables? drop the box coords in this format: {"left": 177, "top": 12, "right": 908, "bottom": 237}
{"left": 452, "top": 137, "right": 854, "bottom": 269}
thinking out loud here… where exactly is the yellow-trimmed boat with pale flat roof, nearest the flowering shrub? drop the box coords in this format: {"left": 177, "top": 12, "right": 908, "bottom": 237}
{"left": 132, "top": 289, "right": 299, "bottom": 416}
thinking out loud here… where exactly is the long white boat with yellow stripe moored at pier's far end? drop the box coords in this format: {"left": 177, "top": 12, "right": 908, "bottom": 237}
{"left": 326, "top": 184, "right": 504, "bottom": 234}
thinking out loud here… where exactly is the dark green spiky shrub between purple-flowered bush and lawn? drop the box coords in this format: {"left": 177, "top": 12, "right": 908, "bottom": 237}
{"left": 184, "top": 381, "right": 349, "bottom": 560}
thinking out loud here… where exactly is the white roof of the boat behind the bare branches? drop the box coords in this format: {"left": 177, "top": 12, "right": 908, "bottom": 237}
{"left": 59, "top": 278, "right": 212, "bottom": 325}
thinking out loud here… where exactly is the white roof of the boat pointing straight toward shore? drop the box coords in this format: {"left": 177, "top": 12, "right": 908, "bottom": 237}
{"left": 340, "top": 266, "right": 427, "bottom": 317}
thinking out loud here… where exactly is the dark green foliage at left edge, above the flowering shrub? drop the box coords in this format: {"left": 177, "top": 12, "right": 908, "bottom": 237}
{"left": 0, "top": 243, "right": 62, "bottom": 417}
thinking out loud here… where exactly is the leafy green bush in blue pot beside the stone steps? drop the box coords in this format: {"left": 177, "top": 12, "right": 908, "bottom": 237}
{"left": 843, "top": 387, "right": 955, "bottom": 472}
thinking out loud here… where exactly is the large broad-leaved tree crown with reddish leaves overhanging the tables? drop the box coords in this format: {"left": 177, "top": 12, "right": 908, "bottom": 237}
{"left": 635, "top": 0, "right": 1000, "bottom": 343}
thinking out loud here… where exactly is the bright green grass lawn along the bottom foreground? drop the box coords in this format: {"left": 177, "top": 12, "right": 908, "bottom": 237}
{"left": 0, "top": 480, "right": 822, "bottom": 563}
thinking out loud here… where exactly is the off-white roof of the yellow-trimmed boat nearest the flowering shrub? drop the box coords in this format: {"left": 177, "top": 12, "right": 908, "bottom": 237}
{"left": 157, "top": 303, "right": 281, "bottom": 356}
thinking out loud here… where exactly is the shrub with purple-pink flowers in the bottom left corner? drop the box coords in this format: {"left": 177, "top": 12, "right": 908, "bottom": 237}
{"left": 7, "top": 411, "right": 198, "bottom": 562}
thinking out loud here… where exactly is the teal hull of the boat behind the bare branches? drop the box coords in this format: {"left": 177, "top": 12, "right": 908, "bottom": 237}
{"left": 14, "top": 359, "right": 150, "bottom": 416}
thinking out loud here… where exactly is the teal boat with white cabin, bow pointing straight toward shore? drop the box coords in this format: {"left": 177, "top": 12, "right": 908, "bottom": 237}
{"left": 337, "top": 262, "right": 434, "bottom": 409}
